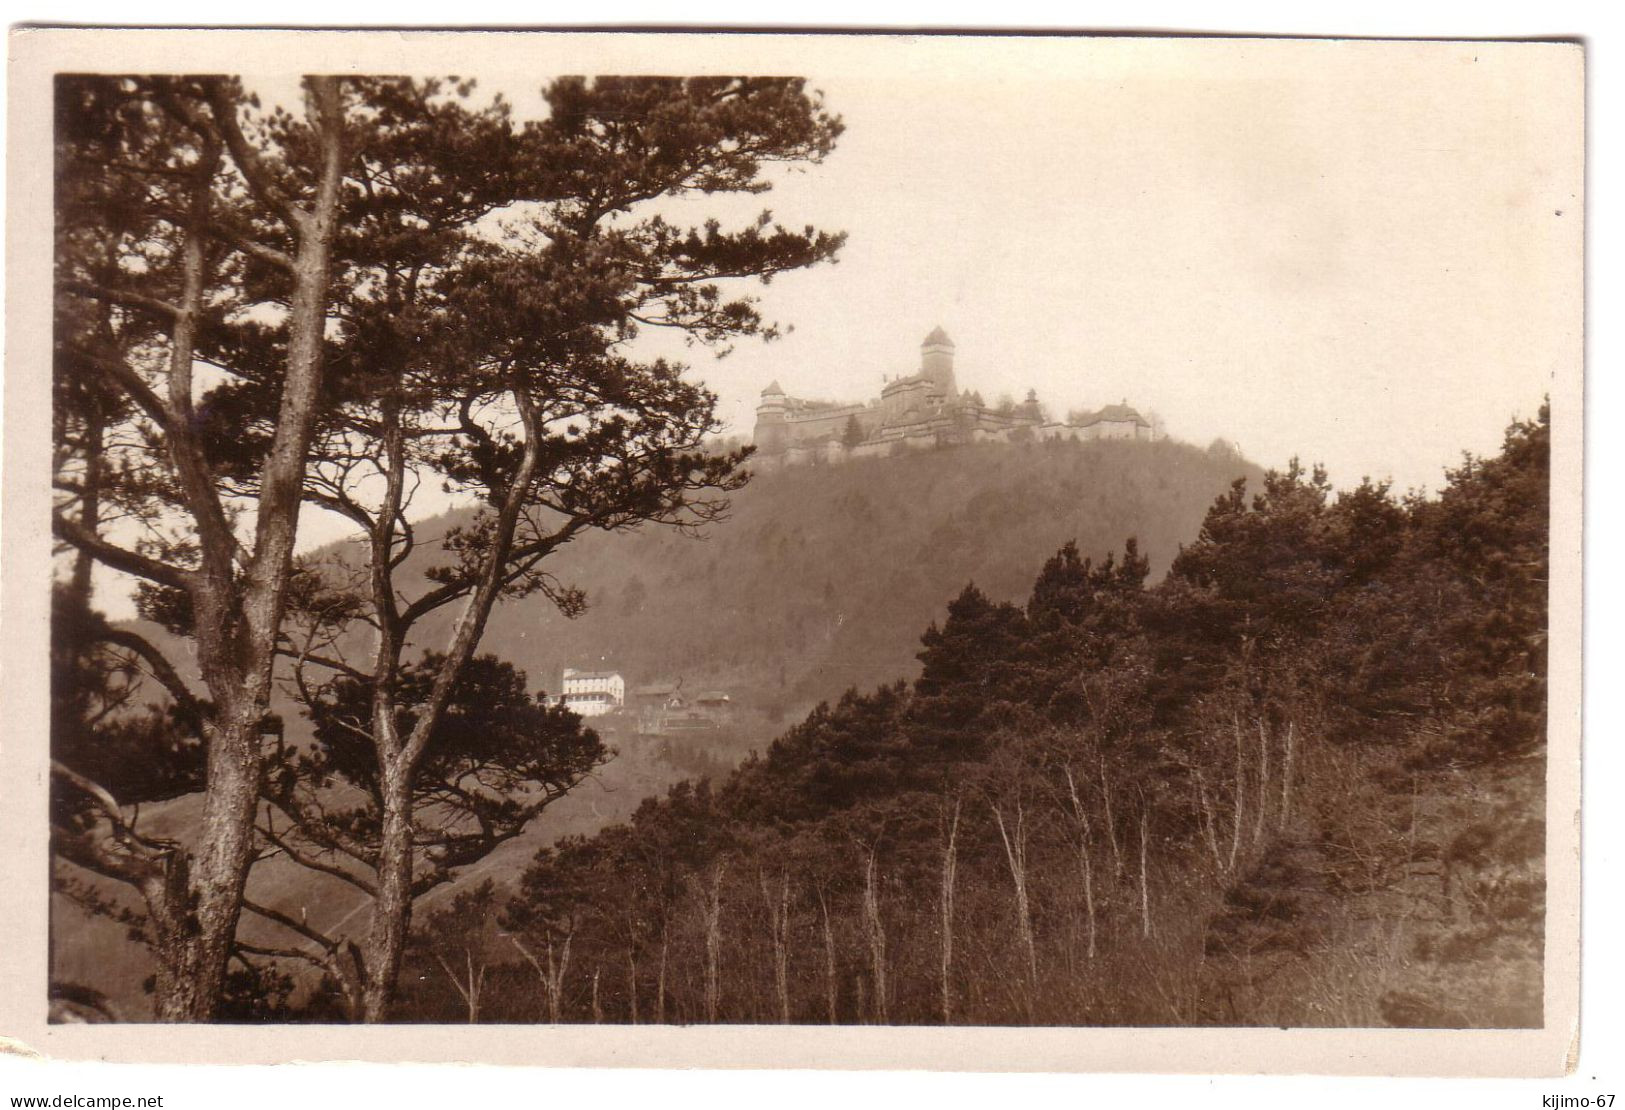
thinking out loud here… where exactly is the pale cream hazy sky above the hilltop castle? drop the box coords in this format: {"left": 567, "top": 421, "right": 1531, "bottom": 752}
{"left": 399, "top": 41, "right": 1581, "bottom": 500}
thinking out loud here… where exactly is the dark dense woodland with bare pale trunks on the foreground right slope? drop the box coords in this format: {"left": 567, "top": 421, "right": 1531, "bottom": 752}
{"left": 386, "top": 410, "right": 1549, "bottom": 1027}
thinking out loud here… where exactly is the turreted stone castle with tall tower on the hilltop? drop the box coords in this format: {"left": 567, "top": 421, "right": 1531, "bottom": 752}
{"left": 752, "top": 327, "right": 1152, "bottom": 466}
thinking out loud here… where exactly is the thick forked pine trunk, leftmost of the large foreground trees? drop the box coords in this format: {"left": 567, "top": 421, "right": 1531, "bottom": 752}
{"left": 156, "top": 78, "right": 345, "bottom": 1021}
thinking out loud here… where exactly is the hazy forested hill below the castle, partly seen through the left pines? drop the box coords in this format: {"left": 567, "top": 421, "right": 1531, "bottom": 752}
{"left": 54, "top": 442, "right": 1261, "bottom": 1014}
